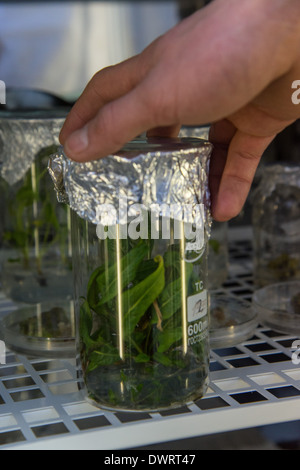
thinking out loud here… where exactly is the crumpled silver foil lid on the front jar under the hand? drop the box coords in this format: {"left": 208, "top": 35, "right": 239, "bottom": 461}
{"left": 48, "top": 138, "right": 212, "bottom": 230}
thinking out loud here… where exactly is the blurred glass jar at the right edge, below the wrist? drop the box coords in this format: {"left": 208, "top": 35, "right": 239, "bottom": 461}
{"left": 252, "top": 164, "right": 300, "bottom": 287}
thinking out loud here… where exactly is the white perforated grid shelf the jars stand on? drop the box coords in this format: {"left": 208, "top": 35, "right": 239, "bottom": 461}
{"left": 0, "top": 231, "right": 300, "bottom": 450}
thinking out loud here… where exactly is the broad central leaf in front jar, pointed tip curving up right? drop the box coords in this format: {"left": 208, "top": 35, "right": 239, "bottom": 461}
{"left": 122, "top": 255, "right": 165, "bottom": 336}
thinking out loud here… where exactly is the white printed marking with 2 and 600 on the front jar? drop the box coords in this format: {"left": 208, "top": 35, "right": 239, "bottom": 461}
{"left": 187, "top": 290, "right": 208, "bottom": 346}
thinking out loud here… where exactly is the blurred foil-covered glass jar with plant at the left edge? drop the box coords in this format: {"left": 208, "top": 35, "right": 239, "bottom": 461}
{"left": 0, "top": 111, "right": 73, "bottom": 304}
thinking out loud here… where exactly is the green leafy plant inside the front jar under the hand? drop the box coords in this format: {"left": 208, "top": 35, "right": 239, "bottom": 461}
{"left": 79, "top": 235, "right": 207, "bottom": 409}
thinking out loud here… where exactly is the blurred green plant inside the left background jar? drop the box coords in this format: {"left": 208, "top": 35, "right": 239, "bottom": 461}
{"left": 4, "top": 145, "right": 67, "bottom": 274}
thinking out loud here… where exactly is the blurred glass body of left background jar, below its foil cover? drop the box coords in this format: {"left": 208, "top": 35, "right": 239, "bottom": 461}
{"left": 2, "top": 147, "right": 73, "bottom": 303}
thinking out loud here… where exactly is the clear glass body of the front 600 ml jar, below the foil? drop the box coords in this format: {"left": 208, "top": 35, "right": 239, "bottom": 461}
{"left": 72, "top": 210, "right": 209, "bottom": 410}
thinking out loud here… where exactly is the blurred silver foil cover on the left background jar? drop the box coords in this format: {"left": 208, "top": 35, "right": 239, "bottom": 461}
{"left": 0, "top": 111, "right": 66, "bottom": 185}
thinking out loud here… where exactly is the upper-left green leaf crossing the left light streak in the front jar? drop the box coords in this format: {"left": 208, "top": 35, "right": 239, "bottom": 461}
{"left": 87, "top": 243, "right": 148, "bottom": 311}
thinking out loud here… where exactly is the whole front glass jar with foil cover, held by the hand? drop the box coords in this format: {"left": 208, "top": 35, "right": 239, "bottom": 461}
{"left": 50, "top": 139, "right": 211, "bottom": 411}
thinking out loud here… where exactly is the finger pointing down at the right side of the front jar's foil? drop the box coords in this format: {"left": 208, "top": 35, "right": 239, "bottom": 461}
{"left": 212, "top": 127, "right": 275, "bottom": 222}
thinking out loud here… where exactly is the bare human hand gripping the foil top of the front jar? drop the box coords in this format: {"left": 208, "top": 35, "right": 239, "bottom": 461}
{"left": 60, "top": 0, "right": 300, "bottom": 221}
